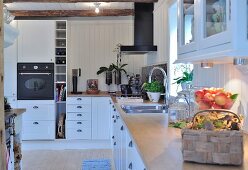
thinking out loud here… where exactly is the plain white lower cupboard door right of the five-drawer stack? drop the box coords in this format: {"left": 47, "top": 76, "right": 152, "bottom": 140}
{"left": 92, "top": 97, "right": 111, "bottom": 140}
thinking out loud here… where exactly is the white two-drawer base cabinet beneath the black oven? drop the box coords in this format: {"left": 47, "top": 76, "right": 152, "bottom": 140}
{"left": 18, "top": 100, "right": 55, "bottom": 140}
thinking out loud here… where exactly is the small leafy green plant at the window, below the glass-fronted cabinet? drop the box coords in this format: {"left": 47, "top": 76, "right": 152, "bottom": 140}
{"left": 173, "top": 70, "right": 193, "bottom": 90}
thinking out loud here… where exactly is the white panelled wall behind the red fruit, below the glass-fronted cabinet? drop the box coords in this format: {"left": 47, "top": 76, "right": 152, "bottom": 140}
{"left": 194, "top": 64, "right": 248, "bottom": 131}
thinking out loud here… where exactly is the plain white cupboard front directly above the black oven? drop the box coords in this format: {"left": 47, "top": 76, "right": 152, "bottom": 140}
{"left": 18, "top": 20, "right": 55, "bottom": 62}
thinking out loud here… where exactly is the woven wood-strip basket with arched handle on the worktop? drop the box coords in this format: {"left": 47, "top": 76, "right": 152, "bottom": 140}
{"left": 182, "top": 110, "right": 243, "bottom": 165}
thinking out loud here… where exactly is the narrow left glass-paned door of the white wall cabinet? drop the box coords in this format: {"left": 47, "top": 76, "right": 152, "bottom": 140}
{"left": 178, "top": 0, "right": 198, "bottom": 54}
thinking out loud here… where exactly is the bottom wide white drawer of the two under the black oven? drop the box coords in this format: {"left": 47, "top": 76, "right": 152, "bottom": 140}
{"left": 22, "top": 121, "right": 55, "bottom": 140}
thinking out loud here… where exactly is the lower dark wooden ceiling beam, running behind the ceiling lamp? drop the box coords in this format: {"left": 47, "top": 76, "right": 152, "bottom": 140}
{"left": 10, "top": 9, "right": 134, "bottom": 18}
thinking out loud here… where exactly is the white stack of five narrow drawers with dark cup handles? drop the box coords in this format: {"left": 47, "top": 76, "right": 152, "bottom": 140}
{"left": 65, "top": 97, "right": 92, "bottom": 139}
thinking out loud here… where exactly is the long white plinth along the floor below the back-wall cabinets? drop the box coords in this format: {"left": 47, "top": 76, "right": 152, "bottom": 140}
{"left": 22, "top": 139, "right": 111, "bottom": 150}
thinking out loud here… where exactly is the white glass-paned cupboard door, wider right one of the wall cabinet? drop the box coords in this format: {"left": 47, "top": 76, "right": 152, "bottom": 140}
{"left": 199, "top": 0, "right": 234, "bottom": 49}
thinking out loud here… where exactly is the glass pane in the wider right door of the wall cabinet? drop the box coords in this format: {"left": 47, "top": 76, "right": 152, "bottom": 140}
{"left": 204, "top": 0, "right": 227, "bottom": 38}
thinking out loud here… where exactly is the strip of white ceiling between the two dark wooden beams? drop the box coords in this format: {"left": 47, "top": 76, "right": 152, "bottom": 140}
{"left": 6, "top": 2, "right": 134, "bottom": 10}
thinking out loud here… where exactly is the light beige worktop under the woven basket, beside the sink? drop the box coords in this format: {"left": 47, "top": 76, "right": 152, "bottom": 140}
{"left": 112, "top": 101, "right": 248, "bottom": 170}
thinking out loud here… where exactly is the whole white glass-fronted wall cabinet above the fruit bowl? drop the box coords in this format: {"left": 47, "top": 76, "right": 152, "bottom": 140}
{"left": 177, "top": 0, "right": 248, "bottom": 63}
